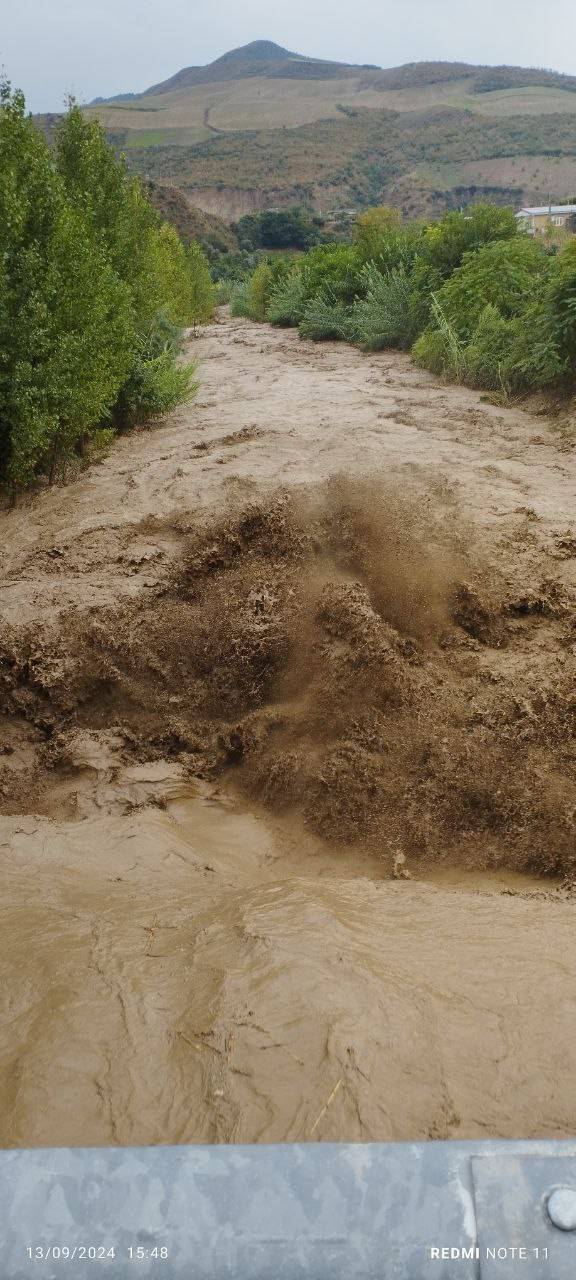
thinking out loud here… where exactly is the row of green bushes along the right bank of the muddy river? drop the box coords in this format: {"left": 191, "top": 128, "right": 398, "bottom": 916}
{"left": 233, "top": 205, "right": 576, "bottom": 396}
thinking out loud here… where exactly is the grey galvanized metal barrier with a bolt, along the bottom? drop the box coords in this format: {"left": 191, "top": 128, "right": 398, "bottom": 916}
{"left": 0, "top": 1142, "right": 576, "bottom": 1280}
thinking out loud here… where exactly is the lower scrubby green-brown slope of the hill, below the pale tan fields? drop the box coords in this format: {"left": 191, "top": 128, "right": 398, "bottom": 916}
{"left": 120, "top": 110, "right": 576, "bottom": 216}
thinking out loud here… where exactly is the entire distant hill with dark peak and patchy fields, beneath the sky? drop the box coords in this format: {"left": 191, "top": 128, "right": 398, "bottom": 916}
{"left": 81, "top": 41, "right": 576, "bottom": 220}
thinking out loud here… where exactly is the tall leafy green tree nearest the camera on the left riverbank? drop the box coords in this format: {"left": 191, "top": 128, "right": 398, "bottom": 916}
{"left": 0, "top": 84, "right": 134, "bottom": 489}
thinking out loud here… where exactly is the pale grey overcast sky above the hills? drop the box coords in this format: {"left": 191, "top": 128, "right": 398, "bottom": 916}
{"left": 0, "top": 0, "right": 576, "bottom": 111}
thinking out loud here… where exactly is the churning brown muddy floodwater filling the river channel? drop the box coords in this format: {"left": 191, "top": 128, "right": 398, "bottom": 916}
{"left": 0, "top": 312, "right": 576, "bottom": 1146}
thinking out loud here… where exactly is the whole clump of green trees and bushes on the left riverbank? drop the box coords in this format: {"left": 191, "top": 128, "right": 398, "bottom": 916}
{"left": 0, "top": 84, "right": 212, "bottom": 493}
